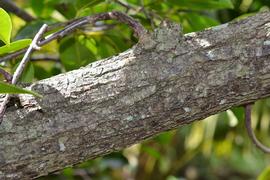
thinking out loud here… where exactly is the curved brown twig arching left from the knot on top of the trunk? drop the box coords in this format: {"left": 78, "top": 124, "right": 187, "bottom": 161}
{"left": 0, "top": 11, "right": 146, "bottom": 62}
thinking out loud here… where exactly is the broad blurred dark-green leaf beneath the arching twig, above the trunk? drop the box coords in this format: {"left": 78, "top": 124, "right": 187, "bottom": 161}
{"left": 59, "top": 37, "right": 95, "bottom": 70}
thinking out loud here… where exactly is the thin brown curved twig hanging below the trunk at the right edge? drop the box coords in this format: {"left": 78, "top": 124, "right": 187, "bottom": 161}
{"left": 244, "top": 104, "right": 270, "bottom": 153}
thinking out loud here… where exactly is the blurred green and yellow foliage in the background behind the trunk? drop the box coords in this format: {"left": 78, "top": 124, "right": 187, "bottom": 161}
{"left": 0, "top": 0, "right": 270, "bottom": 180}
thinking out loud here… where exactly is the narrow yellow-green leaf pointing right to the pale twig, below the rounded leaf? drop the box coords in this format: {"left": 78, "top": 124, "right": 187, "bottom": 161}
{"left": 0, "top": 39, "right": 32, "bottom": 55}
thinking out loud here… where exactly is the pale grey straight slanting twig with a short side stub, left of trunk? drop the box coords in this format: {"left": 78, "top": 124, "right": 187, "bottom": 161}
{"left": 0, "top": 24, "right": 48, "bottom": 124}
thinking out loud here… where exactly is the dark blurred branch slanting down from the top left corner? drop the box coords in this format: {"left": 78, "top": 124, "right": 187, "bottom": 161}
{"left": 0, "top": 0, "right": 35, "bottom": 22}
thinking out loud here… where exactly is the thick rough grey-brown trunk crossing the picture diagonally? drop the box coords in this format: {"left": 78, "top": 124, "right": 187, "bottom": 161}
{"left": 0, "top": 13, "right": 270, "bottom": 179}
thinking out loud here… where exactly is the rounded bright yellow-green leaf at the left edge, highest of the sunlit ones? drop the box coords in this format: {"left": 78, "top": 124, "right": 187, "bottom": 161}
{"left": 0, "top": 8, "right": 12, "bottom": 44}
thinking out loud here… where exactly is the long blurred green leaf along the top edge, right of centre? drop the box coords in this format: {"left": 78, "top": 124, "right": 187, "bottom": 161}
{"left": 168, "top": 0, "right": 234, "bottom": 10}
